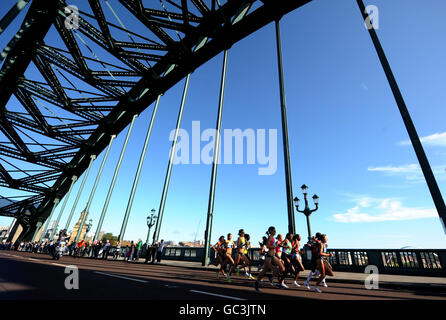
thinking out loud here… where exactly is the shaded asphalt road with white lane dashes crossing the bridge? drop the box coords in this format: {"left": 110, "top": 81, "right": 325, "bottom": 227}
{"left": 0, "top": 251, "right": 446, "bottom": 301}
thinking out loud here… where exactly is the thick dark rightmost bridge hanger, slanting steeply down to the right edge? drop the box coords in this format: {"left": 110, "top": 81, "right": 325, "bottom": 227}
{"left": 356, "top": 0, "right": 446, "bottom": 233}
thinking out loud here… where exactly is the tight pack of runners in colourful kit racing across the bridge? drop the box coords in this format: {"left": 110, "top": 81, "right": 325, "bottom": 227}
{"left": 213, "top": 227, "right": 334, "bottom": 293}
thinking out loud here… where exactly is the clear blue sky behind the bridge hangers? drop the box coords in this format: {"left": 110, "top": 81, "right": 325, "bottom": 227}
{"left": 0, "top": 0, "right": 446, "bottom": 248}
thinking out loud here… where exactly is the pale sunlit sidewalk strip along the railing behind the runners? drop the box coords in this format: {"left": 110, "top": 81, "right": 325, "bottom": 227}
{"left": 154, "top": 260, "right": 446, "bottom": 293}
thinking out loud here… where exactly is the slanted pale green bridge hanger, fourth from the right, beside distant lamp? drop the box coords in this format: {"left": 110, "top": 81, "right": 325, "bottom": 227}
{"left": 153, "top": 73, "right": 191, "bottom": 243}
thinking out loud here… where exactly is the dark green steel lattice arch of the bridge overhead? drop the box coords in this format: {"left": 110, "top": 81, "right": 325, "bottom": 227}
{"left": 0, "top": 0, "right": 311, "bottom": 240}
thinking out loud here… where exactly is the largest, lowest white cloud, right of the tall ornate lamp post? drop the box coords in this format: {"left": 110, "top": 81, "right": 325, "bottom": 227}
{"left": 333, "top": 197, "right": 438, "bottom": 223}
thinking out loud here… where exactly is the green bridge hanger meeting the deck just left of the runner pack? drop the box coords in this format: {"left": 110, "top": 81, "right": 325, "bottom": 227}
{"left": 202, "top": 50, "right": 228, "bottom": 266}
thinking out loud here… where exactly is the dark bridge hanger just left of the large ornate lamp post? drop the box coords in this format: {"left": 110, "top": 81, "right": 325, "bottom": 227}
{"left": 276, "top": 20, "right": 296, "bottom": 234}
